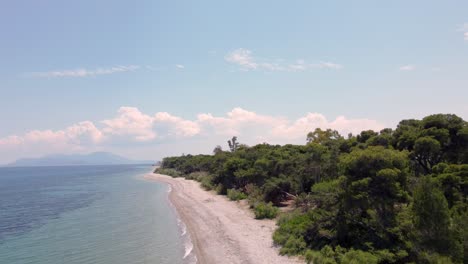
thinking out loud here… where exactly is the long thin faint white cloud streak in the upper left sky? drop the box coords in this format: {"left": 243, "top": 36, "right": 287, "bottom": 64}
{"left": 29, "top": 65, "right": 140, "bottom": 78}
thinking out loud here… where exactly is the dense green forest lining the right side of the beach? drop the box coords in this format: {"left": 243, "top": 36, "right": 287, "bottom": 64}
{"left": 157, "top": 114, "right": 468, "bottom": 264}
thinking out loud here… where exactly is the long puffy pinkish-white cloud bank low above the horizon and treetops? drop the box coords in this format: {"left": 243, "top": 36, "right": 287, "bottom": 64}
{"left": 0, "top": 107, "right": 384, "bottom": 146}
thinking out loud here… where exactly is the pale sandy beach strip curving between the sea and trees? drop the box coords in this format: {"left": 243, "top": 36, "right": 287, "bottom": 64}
{"left": 145, "top": 173, "right": 303, "bottom": 264}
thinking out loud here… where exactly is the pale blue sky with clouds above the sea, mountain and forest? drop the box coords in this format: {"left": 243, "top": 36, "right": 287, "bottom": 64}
{"left": 0, "top": 0, "right": 468, "bottom": 164}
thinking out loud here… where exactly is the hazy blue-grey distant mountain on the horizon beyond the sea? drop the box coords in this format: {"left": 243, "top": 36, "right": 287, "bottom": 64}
{"left": 7, "top": 152, "right": 155, "bottom": 167}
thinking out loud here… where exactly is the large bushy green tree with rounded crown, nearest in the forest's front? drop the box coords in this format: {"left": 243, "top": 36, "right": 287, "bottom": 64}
{"left": 337, "top": 146, "right": 408, "bottom": 249}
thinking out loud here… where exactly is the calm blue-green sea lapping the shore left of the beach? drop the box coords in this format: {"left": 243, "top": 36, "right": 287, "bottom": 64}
{"left": 0, "top": 165, "right": 196, "bottom": 264}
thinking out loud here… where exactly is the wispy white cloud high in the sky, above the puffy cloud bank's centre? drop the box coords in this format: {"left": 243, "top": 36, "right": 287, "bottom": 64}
{"left": 224, "top": 48, "right": 343, "bottom": 72}
